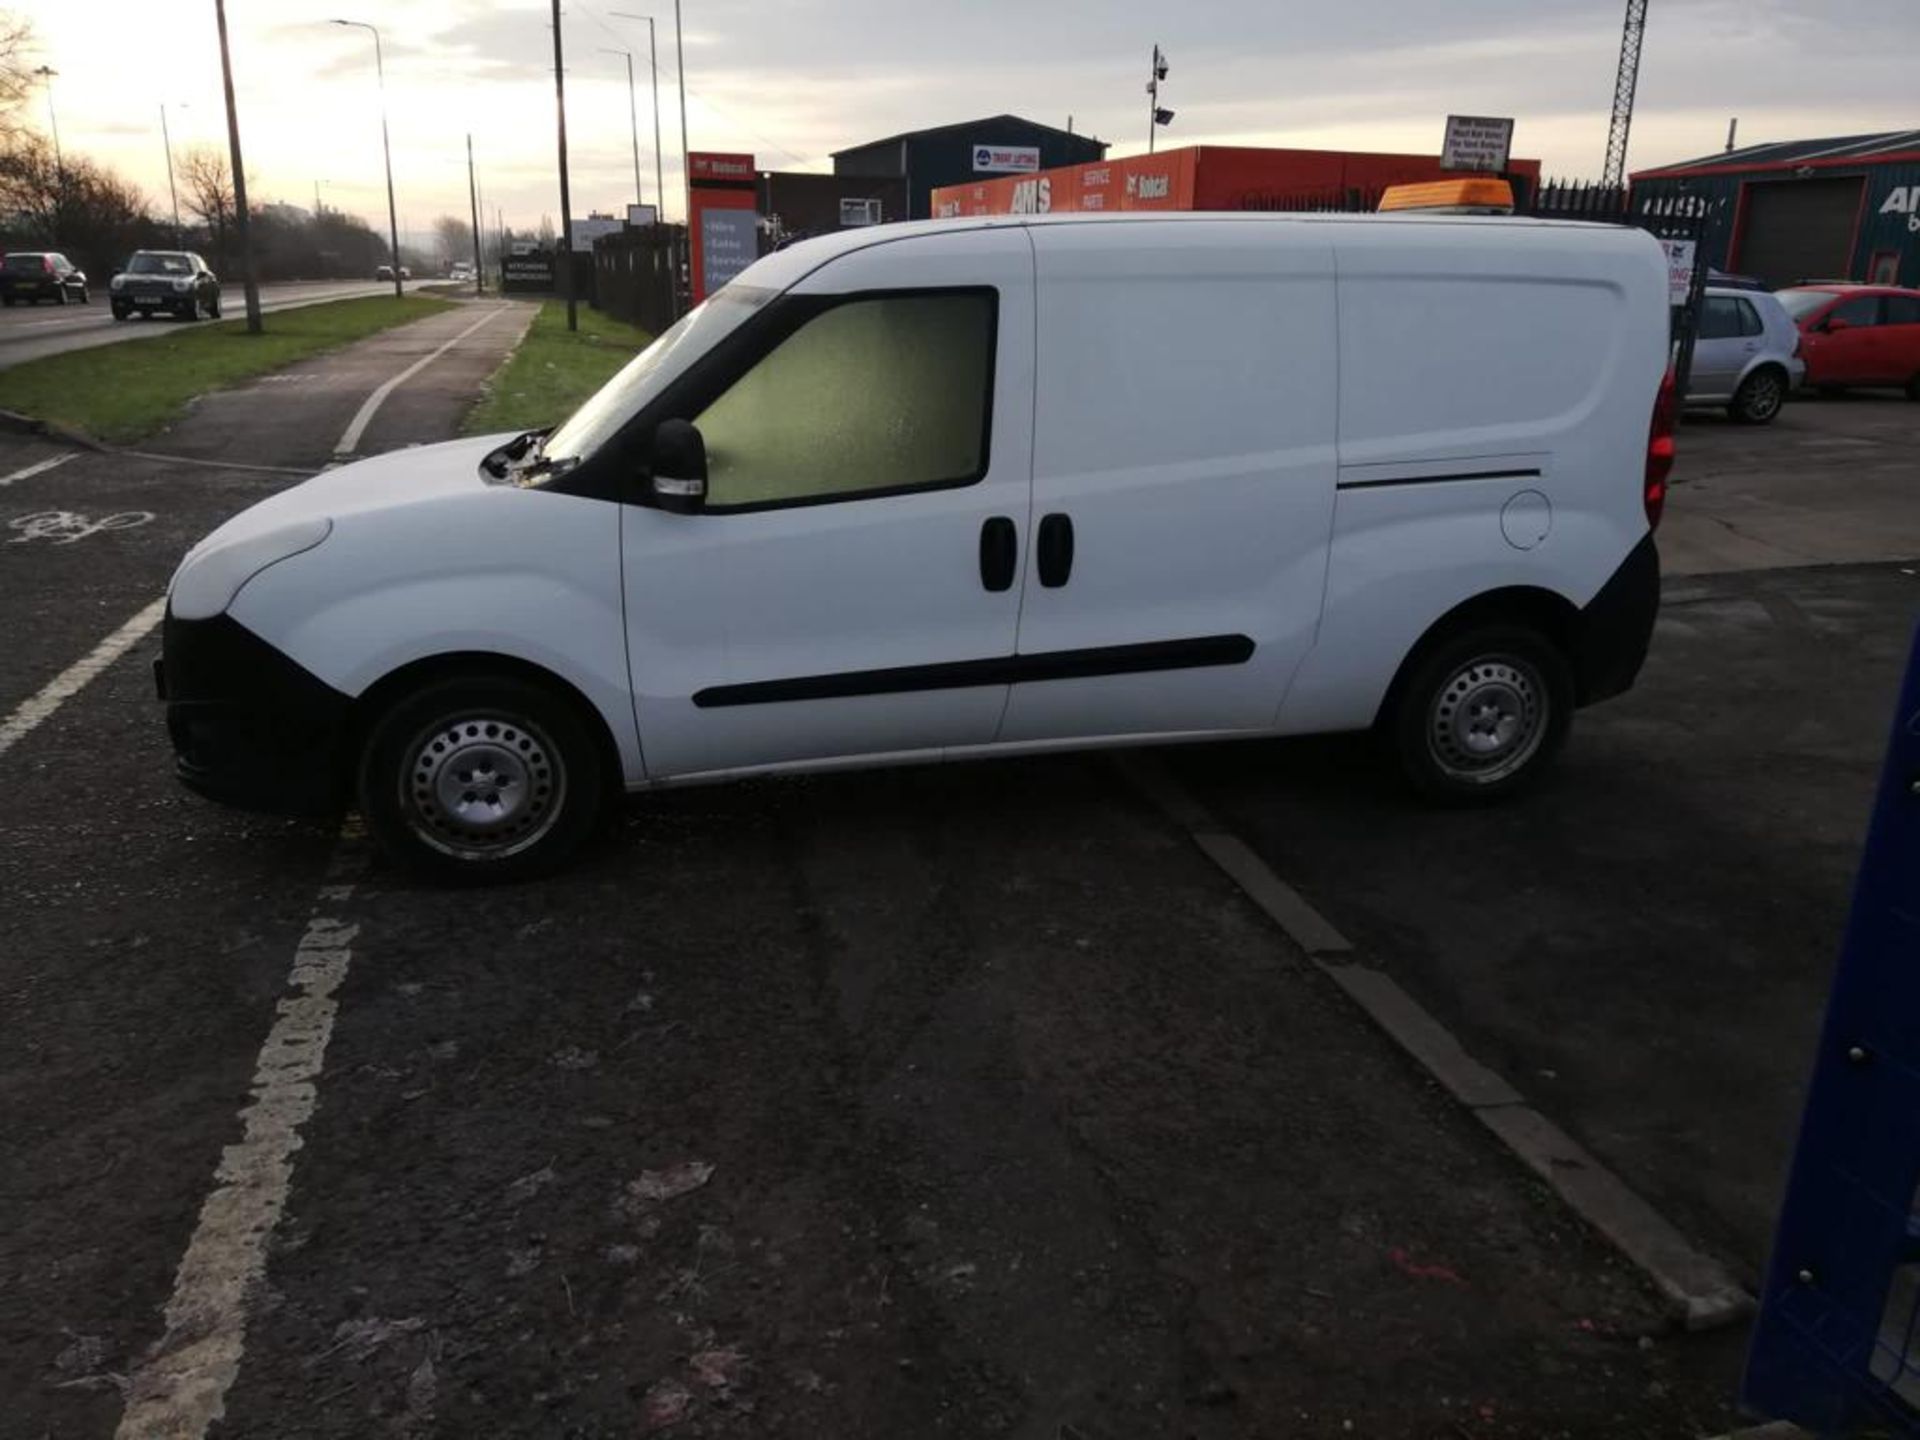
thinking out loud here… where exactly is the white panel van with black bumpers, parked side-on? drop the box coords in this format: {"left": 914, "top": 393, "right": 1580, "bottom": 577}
{"left": 159, "top": 215, "right": 1672, "bottom": 879}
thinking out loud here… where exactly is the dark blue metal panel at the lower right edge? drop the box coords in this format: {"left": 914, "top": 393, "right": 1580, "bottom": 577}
{"left": 1741, "top": 634, "right": 1920, "bottom": 1436}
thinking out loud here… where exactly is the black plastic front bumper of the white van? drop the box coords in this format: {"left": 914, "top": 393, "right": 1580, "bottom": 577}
{"left": 154, "top": 612, "right": 351, "bottom": 816}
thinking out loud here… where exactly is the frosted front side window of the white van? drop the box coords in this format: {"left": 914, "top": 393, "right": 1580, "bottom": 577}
{"left": 693, "top": 290, "right": 995, "bottom": 511}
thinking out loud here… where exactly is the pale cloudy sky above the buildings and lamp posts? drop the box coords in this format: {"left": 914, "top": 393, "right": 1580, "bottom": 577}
{"left": 15, "top": 0, "right": 1920, "bottom": 248}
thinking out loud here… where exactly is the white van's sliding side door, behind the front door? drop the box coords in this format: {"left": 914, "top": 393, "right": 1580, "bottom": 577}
{"left": 1000, "top": 217, "right": 1338, "bottom": 741}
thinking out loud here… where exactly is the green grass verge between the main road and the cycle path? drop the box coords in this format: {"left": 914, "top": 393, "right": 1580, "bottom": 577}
{"left": 0, "top": 296, "right": 451, "bottom": 442}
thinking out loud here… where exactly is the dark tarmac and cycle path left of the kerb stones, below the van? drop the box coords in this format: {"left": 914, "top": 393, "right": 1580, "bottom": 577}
{"left": 0, "top": 305, "right": 1738, "bottom": 1440}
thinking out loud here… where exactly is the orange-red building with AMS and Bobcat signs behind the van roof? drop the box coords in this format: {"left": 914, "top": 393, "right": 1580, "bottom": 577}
{"left": 933, "top": 146, "right": 1540, "bottom": 217}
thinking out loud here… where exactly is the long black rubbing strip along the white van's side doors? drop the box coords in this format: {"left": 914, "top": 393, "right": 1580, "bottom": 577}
{"left": 693, "top": 636, "right": 1254, "bottom": 710}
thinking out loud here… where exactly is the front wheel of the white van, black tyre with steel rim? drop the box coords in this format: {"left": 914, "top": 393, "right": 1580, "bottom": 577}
{"left": 359, "top": 674, "right": 607, "bottom": 885}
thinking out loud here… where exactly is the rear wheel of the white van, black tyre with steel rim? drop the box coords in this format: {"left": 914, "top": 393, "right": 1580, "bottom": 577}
{"left": 1388, "top": 624, "right": 1572, "bottom": 804}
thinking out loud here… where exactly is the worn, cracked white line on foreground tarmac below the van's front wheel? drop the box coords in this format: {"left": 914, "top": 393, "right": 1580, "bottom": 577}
{"left": 113, "top": 851, "right": 359, "bottom": 1440}
